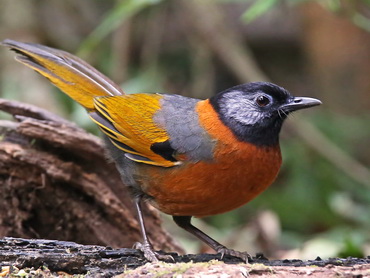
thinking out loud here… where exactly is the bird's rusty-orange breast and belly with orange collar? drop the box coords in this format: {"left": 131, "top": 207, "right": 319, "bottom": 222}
{"left": 138, "top": 100, "right": 281, "bottom": 217}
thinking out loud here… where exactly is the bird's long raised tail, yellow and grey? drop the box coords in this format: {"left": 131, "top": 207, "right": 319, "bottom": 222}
{"left": 2, "top": 40, "right": 124, "bottom": 111}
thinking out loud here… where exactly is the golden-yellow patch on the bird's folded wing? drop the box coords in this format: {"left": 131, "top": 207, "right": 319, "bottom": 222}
{"left": 90, "top": 94, "right": 177, "bottom": 167}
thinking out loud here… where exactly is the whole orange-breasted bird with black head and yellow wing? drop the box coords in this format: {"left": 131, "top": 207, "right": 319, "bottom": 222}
{"left": 2, "top": 39, "right": 321, "bottom": 262}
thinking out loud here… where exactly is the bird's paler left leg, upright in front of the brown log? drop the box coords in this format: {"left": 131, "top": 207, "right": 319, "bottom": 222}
{"left": 134, "top": 197, "right": 174, "bottom": 262}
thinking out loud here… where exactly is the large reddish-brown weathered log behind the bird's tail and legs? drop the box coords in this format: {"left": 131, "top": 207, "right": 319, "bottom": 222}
{"left": 0, "top": 99, "right": 181, "bottom": 251}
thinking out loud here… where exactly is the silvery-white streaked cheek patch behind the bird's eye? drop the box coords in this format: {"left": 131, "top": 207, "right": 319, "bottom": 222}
{"left": 222, "top": 91, "right": 264, "bottom": 125}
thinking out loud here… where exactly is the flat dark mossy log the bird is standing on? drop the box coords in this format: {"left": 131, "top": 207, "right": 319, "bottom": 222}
{"left": 0, "top": 238, "right": 370, "bottom": 277}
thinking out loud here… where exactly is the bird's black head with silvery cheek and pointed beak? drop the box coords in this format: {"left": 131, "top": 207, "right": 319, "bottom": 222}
{"left": 210, "top": 82, "right": 321, "bottom": 146}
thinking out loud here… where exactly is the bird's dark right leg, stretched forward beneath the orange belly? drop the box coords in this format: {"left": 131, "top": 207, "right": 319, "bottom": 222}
{"left": 173, "top": 216, "right": 250, "bottom": 262}
